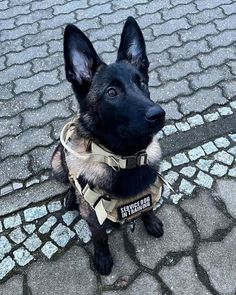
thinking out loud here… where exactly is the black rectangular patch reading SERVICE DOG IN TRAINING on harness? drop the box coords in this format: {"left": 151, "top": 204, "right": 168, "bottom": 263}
{"left": 117, "top": 194, "right": 152, "bottom": 219}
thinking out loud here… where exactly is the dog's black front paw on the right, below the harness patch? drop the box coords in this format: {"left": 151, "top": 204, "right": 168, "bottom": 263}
{"left": 142, "top": 211, "right": 164, "bottom": 238}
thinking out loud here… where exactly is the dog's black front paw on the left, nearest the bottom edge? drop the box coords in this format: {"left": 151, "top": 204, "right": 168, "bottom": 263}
{"left": 94, "top": 251, "right": 113, "bottom": 275}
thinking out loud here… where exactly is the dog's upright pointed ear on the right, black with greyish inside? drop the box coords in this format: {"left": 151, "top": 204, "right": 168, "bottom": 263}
{"left": 117, "top": 16, "right": 149, "bottom": 75}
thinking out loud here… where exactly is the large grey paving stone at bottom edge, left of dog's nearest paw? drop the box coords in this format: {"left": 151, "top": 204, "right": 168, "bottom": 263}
{"left": 27, "top": 246, "right": 96, "bottom": 295}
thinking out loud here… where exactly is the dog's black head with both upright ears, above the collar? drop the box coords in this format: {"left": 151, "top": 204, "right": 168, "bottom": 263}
{"left": 64, "top": 17, "right": 165, "bottom": 155}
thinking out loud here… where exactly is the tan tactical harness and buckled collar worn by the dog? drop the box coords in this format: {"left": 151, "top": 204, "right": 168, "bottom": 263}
{"left": 60, "top": 121, "right": 169, "bottom": 224}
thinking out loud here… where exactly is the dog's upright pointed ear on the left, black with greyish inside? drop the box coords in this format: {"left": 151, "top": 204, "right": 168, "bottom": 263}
{"left": 64, "top": 24, "right": 102, "bottom": 86}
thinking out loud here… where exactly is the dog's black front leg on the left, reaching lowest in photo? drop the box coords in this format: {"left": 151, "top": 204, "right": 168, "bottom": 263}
{"left": 89, "top": 220, "right": 113, "bottom": 275}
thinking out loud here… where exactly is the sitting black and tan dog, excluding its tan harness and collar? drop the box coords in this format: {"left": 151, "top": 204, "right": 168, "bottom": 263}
{"left": 52, "top": 17, "right": 165, "bottom": 274}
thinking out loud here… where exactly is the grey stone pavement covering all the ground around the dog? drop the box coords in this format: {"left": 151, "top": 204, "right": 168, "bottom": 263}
{"left": 0, "top": 0, "right": 236, "bottom": 295}
